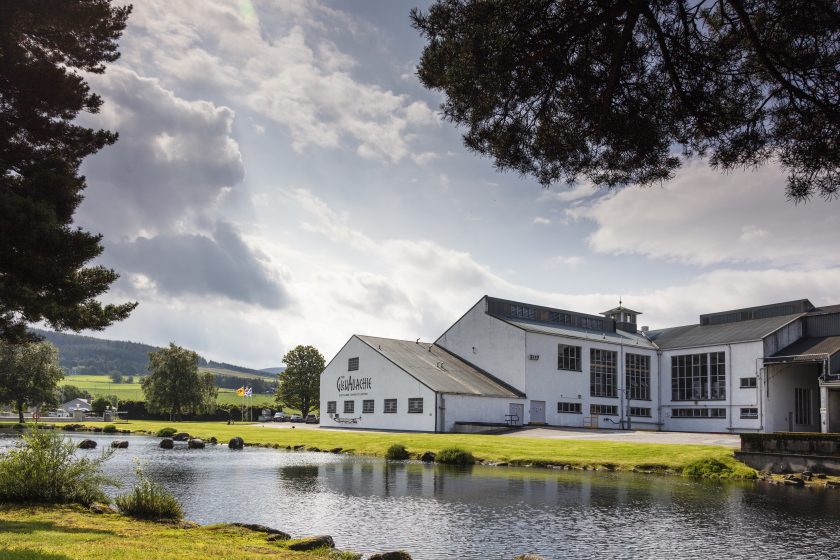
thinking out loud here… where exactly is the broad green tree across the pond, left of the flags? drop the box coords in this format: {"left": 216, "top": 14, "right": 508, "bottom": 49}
{"left": 141, "top": 343, "right": 218, "bottom": 420}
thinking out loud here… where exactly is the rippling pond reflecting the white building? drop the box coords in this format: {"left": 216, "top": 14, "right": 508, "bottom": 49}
{"left": 0, "top": 434, "right": 840, "bottom": 560}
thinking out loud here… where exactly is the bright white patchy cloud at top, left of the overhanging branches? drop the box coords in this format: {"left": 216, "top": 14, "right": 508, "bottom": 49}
{"left": 123, "top": 0, "right": 439, "bottom": 163}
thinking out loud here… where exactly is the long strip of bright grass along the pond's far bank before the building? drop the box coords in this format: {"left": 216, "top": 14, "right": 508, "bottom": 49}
{"left": 74, "top": 420, "right": 756, "bottom": 478}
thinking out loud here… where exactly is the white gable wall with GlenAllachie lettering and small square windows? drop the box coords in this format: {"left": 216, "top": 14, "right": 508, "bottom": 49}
{"left": 321, "top": 336, "right": 436, "bottom": 432}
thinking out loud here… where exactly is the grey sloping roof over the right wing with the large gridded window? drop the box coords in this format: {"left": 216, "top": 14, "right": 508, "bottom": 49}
{"left": 648, "top": 313, "right": 803, "bottom": 350}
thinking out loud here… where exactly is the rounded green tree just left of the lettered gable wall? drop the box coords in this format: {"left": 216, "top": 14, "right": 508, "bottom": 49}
{"left": 276, "top": 346, "right": 325, "bottom": 418}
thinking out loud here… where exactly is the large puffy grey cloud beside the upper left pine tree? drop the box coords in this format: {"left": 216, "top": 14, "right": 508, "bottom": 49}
{"left": 77, "top": 67, "right": 245, "bottom": 238}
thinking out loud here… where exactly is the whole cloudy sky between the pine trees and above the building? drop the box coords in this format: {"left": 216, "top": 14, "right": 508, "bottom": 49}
{"left": 76, "top": 0, "right": 840, "bottom": 368}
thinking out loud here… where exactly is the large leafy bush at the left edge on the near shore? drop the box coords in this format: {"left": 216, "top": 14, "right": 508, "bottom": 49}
{"left": 0, "top": 430, "right": 117, "bottom": 505}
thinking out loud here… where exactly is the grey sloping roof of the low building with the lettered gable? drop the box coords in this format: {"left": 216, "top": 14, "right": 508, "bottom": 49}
{"left": 356, "top": 335, "right": 525, "bottom": 398}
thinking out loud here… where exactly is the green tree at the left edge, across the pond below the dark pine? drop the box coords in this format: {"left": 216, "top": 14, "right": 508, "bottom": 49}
{"left": 0, "top": 342, "right": 64, "bottom": 423}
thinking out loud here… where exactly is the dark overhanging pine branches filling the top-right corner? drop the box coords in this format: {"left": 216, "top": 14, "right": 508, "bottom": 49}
{"left": 411, "top": 0, "right": 840, "bottom": 201}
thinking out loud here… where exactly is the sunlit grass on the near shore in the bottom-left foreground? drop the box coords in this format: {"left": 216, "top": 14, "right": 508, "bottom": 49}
{"left": 0, "top": 505, "right": 348, "bottom": 560}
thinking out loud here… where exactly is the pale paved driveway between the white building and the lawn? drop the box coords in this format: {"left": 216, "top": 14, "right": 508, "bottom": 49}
{"left": 261, "top": 422, "right": 741, "bottom": 447}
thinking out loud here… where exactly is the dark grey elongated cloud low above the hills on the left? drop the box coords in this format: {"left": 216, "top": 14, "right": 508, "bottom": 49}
{"left": 106, "top": 222, "right": 290, "bottom": 309}
